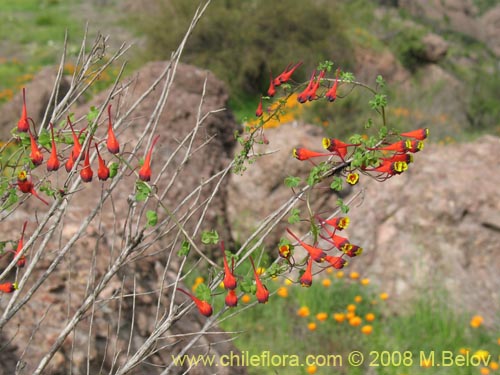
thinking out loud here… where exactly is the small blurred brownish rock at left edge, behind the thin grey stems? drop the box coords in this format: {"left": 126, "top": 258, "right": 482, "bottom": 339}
{"left": 0, "top": 67, "right": 70, "bottom": 140}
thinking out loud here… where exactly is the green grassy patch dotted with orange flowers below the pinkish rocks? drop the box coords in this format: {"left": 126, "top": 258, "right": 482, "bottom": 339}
{"left": 213, "top": 273, "right": 499, "bottom": 375}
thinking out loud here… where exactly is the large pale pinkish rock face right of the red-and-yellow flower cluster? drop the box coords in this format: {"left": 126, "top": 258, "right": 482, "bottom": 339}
{"left": 349, "top": 136, "right": 500, "bottom": 322}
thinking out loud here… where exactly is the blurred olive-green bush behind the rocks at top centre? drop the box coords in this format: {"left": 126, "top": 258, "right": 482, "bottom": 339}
{"left": 131, "top": 0, "right": 353, "bottom": 101}
